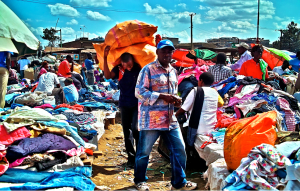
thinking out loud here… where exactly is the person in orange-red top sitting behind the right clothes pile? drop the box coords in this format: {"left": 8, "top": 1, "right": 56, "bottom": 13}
{"left": 239, "top": 45, "right": 275, "bottom": 81}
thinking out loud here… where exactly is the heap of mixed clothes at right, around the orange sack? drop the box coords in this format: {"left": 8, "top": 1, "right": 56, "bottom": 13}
{"left": 195, "top": 74, "right": 300, "bottom": 190}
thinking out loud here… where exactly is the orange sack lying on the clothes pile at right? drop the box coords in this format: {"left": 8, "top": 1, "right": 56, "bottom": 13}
{"left": 224, "top": 111, "right": 277, "bottom": 170}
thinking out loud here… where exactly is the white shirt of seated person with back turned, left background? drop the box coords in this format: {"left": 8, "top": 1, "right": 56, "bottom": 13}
{"left": 35, "top": 72, "right": 59, "bottom": 95}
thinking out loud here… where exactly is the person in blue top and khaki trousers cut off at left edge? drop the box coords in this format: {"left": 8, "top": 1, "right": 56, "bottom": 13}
{"left": 0, "top": 52, "right": 11, "bottom": 108}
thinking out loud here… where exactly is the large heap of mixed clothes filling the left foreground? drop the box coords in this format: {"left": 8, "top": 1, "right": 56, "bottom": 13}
{"left": 0, "top": 91, "right": 117, "bottom": 191}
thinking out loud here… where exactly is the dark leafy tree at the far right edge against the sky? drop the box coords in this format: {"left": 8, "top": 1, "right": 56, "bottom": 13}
{"left": 273, "top": 21, "right": 300, "bottom": 52}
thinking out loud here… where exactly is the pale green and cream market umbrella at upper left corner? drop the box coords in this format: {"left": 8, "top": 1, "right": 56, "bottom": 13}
{"left": 0, "top": 0, "right": 39, "bottom": 55}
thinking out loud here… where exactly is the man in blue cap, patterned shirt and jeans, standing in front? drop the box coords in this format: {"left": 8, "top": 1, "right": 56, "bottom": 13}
{"left": 134, "top": 40, "right": 197, "bottom": 190}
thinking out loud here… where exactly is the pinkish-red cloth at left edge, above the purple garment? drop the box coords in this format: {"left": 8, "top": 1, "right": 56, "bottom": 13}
{"left": 0, "top": 125, "right": 31, "bottom": 145}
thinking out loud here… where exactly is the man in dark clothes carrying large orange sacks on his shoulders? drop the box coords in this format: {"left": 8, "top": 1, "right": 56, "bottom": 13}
{"left": 104, "top": 46, "right": 141, "bottom": 167}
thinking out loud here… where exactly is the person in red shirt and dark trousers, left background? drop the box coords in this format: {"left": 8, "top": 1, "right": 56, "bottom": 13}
{"left": 58, "top": 55, "right": 86, "bottom": 90}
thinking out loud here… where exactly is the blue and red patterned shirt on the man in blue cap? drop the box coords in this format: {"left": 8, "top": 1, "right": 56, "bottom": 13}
{"left": 135, "top": 61, "right": 179, "bottom": 130}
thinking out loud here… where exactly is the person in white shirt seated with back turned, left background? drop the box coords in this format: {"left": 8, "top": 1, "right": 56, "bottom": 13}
{"left": 35, "top": 71, "right": 67, "bottom": 105}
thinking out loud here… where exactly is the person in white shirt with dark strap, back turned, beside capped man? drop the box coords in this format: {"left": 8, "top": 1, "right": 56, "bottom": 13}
{"left": 176, "top": 72, "right": 219, "bottom": 140}
